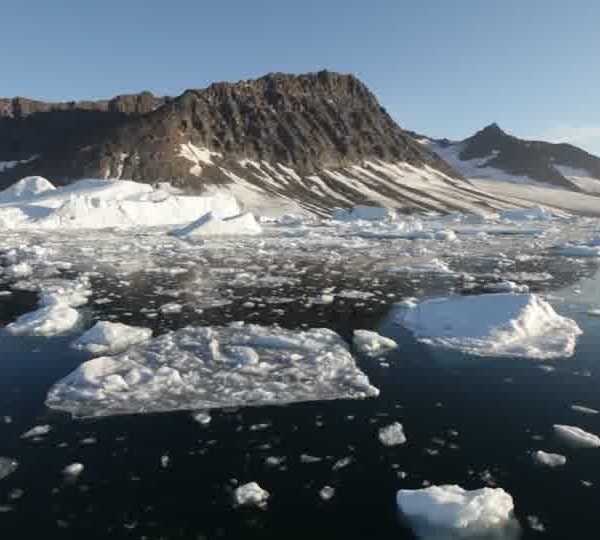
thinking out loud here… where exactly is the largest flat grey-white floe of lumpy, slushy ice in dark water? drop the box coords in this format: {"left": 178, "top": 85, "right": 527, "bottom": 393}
{"left": 46, "top": 323, "right": 379, "bottom": 416}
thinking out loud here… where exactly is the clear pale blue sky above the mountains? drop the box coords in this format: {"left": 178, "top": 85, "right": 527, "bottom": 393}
{"left": 0, "top": 0, "right": 600, "bottom": 154}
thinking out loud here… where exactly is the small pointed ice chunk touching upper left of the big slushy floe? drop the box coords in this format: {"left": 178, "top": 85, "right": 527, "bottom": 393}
{"left": 71, "top": 321, "right": 152, "bottom": 354}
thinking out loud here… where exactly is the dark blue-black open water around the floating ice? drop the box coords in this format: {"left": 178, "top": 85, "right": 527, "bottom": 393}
{"left": 0, "top": 262, "right": 600, "bottom": 540}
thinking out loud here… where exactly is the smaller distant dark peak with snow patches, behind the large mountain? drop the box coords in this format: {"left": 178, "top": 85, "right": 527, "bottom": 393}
{"left": 421, "top": 124, "right": 600, "bottom": 195}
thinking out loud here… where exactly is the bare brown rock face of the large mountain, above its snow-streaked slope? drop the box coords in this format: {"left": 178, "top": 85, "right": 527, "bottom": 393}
{"left": 0, "top": 71, "right": 459, "bottom": 213}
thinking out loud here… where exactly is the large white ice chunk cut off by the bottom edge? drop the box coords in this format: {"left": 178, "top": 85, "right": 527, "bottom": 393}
{"left": 396, "top": 485, "right": 518, "bottom": 540}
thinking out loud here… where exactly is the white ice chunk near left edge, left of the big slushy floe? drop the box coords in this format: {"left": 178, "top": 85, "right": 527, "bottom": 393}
{"left": 6, "top": 303, "right": 80, "bottom": 336}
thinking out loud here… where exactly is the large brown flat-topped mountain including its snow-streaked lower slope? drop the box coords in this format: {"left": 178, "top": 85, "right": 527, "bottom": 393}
{"left": 0, "top": 71, "right": 536, "bottom": 215}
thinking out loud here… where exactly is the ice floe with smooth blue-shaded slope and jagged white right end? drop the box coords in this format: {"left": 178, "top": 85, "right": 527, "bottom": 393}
{"left": 396, "top": 293, "right": 582, "bottom": 359}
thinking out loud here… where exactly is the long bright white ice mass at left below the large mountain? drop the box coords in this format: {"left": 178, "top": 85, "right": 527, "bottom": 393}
{"left": 0, "top": 177, "right": 240, "bottom": 230}
